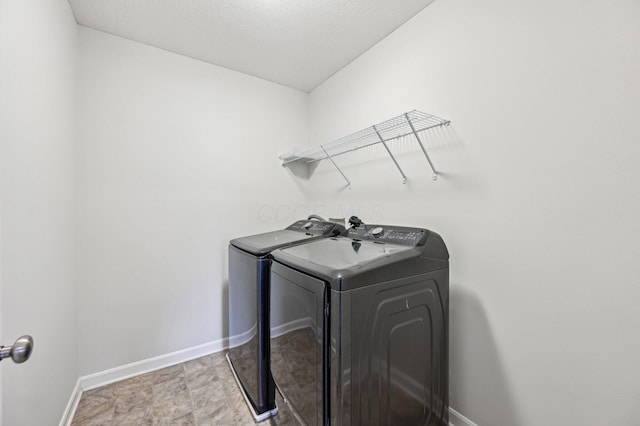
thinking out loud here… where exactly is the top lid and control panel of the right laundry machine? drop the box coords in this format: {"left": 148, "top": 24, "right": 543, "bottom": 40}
{"left": 272, "top": 225, "right": 449, "bottom": 291}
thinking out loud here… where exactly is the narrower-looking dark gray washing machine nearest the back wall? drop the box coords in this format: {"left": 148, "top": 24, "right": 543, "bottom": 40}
{"left": 227, "top": 216, "right": 345, "bottom": 421}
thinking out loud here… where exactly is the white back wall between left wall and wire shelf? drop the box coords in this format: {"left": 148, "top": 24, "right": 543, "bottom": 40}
{"left": 78, "top": 28, "right": 308, "bottom": 375}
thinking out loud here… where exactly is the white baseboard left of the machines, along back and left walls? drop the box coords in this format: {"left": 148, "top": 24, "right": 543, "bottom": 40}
{"left": 60, "top": 338, "right": 229, "bottom": 426}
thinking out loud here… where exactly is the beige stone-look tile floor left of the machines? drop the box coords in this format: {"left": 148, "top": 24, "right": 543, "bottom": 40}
{"left": 71, "top": 352, "right": 292, "bottom": 426}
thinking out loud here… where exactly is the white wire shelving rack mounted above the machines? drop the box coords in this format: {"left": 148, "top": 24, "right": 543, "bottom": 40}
{"left": 282, "top": 110, "right": 451, "bottom": 188}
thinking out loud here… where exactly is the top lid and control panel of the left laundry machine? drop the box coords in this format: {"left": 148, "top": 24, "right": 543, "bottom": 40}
{"left": 230, "top": 220, "right": 345, "bottom": 257}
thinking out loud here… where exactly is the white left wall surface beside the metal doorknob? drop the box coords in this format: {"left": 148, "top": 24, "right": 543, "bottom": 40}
{"left": 0, "top": 0, "right": 78, "bottom": 426}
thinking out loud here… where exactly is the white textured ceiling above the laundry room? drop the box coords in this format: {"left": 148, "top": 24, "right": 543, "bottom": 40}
{"left": 69, "top": 0, "right": 433, "bottom": 92}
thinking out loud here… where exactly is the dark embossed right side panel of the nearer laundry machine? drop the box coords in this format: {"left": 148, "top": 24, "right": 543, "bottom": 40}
{"left": 342, "top": 270, "right": 449, "bottom": 426}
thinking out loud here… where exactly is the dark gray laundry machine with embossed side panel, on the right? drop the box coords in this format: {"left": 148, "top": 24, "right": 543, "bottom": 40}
{"left": 270, "top": 225, "right": 449, "bottom": 426}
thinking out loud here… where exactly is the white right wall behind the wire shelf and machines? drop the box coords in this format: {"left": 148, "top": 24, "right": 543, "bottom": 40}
{"left": 300, "top": 0, "right": 640, "bottom": 426}
